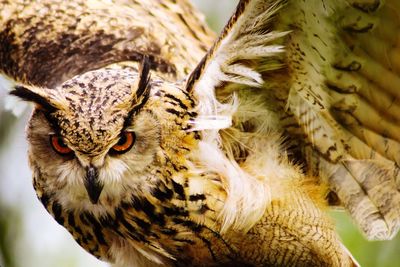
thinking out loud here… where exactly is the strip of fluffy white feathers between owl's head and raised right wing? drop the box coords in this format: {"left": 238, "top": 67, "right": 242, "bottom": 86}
{"left": 192, "top": 1, "right": 287, "bottom": 232}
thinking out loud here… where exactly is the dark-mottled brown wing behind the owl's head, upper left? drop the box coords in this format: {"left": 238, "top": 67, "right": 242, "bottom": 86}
{"left": 0, "top": 0, "right": 214, "bottom": 88}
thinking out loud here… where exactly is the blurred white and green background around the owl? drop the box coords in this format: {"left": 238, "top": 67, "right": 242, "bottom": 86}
{"left": 0, "top": 0, "right": 400, "bottom": 267}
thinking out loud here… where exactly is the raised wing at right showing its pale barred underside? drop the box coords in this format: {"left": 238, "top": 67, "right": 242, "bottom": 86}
{"left": 187, "top": 0, "right": 400, "bottom": 242}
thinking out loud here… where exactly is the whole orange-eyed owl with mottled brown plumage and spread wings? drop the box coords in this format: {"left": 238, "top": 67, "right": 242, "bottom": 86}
{"left": 0, "top": 0, "right": 400, "bottom": 267}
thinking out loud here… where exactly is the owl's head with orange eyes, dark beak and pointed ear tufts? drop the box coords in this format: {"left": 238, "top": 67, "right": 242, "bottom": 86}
{"left": 12, "top": 60, "right": 195, "bottom": 207}
